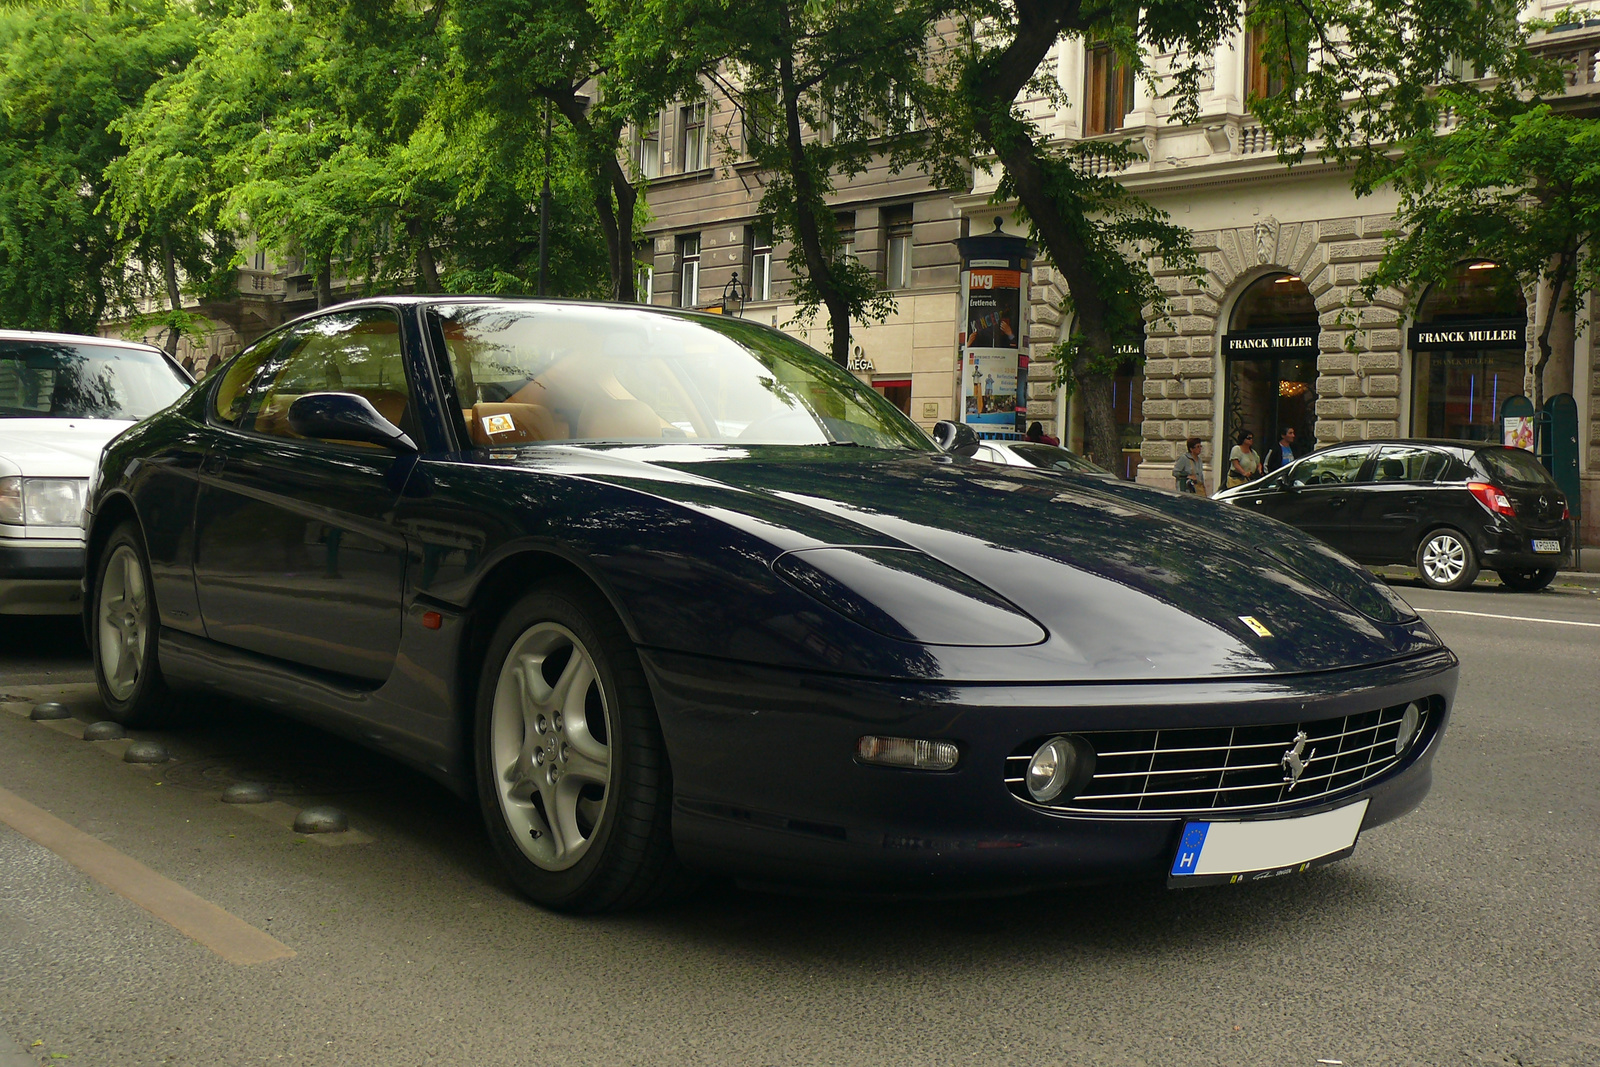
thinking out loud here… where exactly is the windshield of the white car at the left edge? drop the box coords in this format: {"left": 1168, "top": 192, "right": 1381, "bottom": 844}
{"left": 0, "top": 338, "right": 190, "bottom": 421}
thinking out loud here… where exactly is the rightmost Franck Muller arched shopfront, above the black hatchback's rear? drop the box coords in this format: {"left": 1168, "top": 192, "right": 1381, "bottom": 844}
{"left": 1408, "top": 259, "right": 1528, "bottom": 442}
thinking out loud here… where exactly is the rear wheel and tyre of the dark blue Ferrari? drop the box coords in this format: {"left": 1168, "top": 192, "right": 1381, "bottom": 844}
{"left": 88, "top": 522, "right": 181, "bottom": 726}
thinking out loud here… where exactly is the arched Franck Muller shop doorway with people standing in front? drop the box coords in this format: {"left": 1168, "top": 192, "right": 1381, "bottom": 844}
{"left": 1222, "top": 272, "right": 1322, "bottom": 453}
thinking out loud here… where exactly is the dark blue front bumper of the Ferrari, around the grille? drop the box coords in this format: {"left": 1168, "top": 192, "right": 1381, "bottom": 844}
{"left": 642, "top": 649, "right": 1458, "bottom": 893}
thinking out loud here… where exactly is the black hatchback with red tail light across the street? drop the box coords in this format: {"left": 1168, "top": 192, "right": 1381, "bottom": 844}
{"left": 1216, "top": 440, "right": 1573, "bottom": 592}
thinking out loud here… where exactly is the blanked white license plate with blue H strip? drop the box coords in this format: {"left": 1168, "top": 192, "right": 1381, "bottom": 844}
{"left": 1166, "top": 800, "right": 1368, "bottom": 886}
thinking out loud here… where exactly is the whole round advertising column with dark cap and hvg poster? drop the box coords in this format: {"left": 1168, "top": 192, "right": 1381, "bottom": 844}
{"left": 955, "top": 219, "right": 1034, "bottom": 438}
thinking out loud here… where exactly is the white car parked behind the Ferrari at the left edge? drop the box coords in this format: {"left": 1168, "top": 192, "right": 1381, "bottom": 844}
{"left": 0, "top": 330, "right": 194, "bottom": 614}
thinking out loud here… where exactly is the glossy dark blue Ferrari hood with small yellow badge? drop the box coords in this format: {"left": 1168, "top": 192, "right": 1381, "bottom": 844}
{"left": 486, "top": 445, "right": 1438, "bottom": 680}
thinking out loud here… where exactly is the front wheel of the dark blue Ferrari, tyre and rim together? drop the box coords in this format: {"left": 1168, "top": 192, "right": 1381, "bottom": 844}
{"left": 474, "top": 582, "right": 678, "bottom": 912}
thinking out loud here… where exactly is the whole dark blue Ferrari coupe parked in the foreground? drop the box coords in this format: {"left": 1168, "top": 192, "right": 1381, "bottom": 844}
{"left": 85, "top": 298, "right": 1458, "bottom": 910}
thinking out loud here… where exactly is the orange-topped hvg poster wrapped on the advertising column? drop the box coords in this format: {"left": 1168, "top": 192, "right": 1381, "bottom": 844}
{"left": 962, "top": 266, "right": 1022, "bottom": 430}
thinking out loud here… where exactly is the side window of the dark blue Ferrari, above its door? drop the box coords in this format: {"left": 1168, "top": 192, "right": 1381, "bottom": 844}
{"left": 236, "top": 307, "right": 416, "bottom": 437}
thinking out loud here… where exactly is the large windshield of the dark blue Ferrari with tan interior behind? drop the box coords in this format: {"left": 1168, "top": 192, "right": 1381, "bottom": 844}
{"left": 434, "top": 304, "right": 936, "bottom": 451}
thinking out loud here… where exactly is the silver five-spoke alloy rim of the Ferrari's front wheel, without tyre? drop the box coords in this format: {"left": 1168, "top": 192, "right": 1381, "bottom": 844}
{"left": 490, "top": 622, "right": 611, "bottom": 870}
